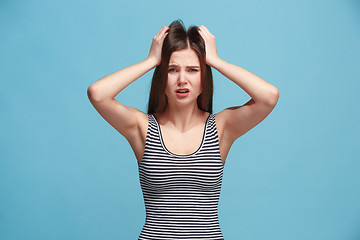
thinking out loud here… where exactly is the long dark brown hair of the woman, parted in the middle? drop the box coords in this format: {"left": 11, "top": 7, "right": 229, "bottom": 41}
{"left": 148, "top": 19, "right": 213, "bottom": 114}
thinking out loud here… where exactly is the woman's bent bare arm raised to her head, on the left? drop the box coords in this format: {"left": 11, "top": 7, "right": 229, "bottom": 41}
{"left": 87, "top": 26, "right": 168, "bottom": 142}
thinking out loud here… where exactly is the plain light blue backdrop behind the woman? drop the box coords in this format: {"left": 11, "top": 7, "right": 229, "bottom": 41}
{"left": 0, "top": 0, "right": 360, "bottom": 240}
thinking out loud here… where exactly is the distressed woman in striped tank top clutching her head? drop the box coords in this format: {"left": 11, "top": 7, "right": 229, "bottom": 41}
{"left": 88, "top": 20, "right": 279, "bottom": 239}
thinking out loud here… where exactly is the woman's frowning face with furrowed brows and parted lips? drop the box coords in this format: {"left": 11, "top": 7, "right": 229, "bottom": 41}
{"left": 165, "top": 48, "right": 202, "bottom": 104}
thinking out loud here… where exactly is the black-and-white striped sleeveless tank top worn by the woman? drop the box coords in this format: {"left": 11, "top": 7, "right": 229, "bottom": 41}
{"left": 138, "top": 114, "right": 224, "bottom": 240}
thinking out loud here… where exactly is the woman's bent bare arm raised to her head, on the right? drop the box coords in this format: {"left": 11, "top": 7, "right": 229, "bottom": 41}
{"left": 199, "top": 25, "right": 279, "bottom": 144}
